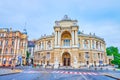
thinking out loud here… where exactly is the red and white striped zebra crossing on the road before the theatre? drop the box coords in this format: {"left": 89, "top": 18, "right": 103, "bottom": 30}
{"left": 52, "top": 71, "right": 99, "bottom": 75}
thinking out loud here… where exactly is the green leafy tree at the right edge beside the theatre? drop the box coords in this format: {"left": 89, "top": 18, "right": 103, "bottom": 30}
{"left": 106, "top": 46, "right": 120, "bottom": 67}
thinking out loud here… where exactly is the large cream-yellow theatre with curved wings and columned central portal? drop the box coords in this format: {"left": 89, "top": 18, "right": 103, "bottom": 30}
{"left": 34, "top": 15, "right": 108, "bottom": 68}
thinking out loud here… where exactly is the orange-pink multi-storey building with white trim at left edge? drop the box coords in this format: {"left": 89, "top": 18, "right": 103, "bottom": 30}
{"left": 0, "top": 28, "right": 27, "bottom": 66}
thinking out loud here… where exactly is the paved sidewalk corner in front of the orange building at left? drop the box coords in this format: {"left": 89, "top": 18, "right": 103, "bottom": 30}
{"left": 0, "top": 68, "right": 22, "bottom": 76}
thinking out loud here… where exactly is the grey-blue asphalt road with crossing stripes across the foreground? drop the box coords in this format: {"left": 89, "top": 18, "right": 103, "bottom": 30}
{"left": 0, "top": 68, "right": 115, "bottom": 80}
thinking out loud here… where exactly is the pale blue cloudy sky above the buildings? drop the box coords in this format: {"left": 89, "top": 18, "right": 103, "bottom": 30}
{"left": 0, "top": 0, "right": 120, "bottom": 49}
